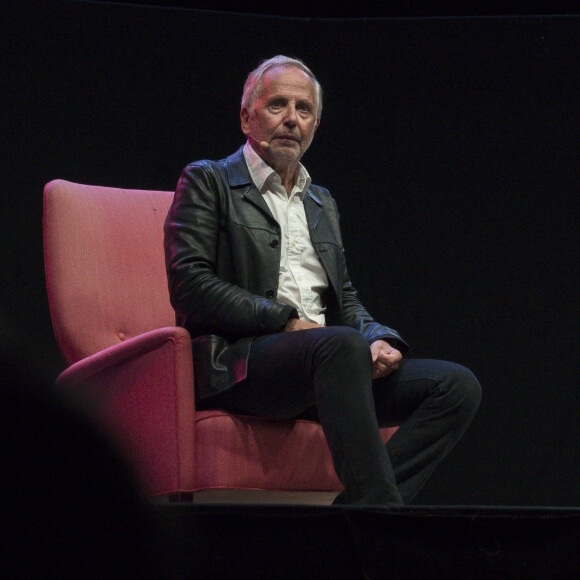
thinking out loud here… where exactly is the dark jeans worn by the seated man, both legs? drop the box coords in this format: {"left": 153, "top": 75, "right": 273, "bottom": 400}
{"left": 203, "top": 326, "right": 481, "bottom": 506}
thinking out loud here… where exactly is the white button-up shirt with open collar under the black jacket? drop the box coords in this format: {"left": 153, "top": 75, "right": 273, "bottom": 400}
{"left": 244, "top": 143, "right": 328, "bottom": 324}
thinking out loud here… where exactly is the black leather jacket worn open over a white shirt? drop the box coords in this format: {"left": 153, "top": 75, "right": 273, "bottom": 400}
{"left": 165, "top": 148, "right": 408, "bottom": 400}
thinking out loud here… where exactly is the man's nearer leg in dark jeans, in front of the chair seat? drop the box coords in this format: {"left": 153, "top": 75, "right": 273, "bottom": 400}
{"left": 204, "top": 327, "right": 402, "bottom": 506}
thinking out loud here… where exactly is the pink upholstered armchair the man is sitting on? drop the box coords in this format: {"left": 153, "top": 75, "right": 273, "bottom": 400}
{"left": 44, "top": 180, "right": 394, "bottom": 503}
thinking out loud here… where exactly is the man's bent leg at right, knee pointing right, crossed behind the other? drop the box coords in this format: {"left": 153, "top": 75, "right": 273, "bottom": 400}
{"left": 373, "top": 359, "right": 481, "bottom": 504}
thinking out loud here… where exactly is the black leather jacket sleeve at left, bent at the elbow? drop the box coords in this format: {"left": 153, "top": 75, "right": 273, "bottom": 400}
{"left": 164, "top": 161, "right": 298, "bottom": 340}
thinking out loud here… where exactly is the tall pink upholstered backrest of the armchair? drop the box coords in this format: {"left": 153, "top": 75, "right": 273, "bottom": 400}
{"left": 44, "top": 180, "right": 175, "bottom": 364}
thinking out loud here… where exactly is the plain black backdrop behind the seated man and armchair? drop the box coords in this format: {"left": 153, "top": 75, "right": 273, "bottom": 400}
{"left": 0, "top": 1, "right": 580, "bottom": 506}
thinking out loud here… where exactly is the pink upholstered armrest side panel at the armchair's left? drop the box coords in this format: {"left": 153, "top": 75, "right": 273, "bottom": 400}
{"left": 56, "top": 327, "right": 195, "bottom": 496}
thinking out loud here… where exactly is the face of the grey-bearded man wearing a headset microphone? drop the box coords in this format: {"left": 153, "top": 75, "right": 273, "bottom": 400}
{"left": 241, "top": 66, "right": 319, "bottom": 169}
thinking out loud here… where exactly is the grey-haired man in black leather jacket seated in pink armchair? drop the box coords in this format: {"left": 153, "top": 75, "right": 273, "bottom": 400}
{"left": 165, "top": 56, "right": 481, "bottom": 506}
